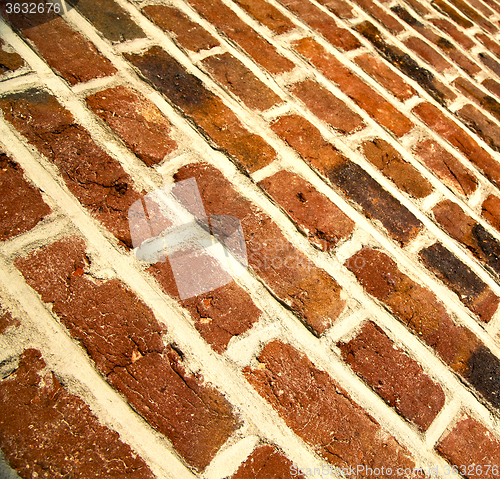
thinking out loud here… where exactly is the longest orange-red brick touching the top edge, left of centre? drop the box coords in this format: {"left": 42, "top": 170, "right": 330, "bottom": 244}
{"left": 188, "top": 0, "right": 294, "bottom": 74}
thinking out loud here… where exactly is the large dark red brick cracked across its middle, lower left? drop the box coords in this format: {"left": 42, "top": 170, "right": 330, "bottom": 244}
{"left": 15, "top": 237, "right": 240, "bottom": 470}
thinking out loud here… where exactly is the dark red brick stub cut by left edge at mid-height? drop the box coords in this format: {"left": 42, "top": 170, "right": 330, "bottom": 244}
{"left": 0, "top": 153, "right": 51, "bottom": 241}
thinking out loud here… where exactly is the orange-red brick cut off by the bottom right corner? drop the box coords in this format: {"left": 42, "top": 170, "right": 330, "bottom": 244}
{"left": 436, "top": 416, "right": 500, "bottom": 479}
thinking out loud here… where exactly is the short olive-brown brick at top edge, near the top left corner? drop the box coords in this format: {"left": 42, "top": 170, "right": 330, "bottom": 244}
{"left": 72, "top": 0, "right": 146, "bottom": 43}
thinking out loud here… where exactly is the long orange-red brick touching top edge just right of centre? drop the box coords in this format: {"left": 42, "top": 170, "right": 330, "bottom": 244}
{"left": 281, "top": 0, "right": 361, "bottom": 51}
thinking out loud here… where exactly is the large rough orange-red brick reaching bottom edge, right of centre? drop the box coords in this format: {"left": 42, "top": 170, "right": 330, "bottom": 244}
{"left": 244, "top": 341, "right": 414, "bottom": 477}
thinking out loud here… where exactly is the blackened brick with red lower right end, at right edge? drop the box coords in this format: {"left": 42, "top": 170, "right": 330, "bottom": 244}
{"left": 419, "top": 243, "right": 500, "bottom": 322}
